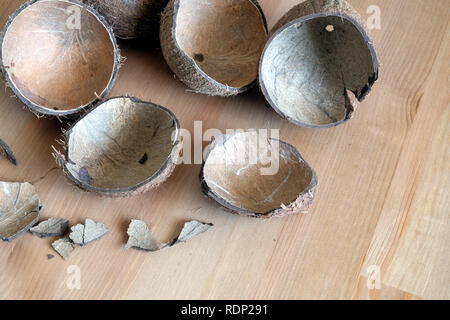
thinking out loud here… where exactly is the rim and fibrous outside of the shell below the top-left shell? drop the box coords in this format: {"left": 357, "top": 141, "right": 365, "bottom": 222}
{"left": 53, "top": 96, "right": 182, "bottom": 198}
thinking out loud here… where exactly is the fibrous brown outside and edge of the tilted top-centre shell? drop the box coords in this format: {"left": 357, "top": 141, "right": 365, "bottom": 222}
{"left": 160, "top": 0, "right": 268, "bottom": 96}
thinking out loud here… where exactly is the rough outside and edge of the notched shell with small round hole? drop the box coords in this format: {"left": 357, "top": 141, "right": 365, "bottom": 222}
{"left": 259, "top": 0, "right": 379, "bottom": 128}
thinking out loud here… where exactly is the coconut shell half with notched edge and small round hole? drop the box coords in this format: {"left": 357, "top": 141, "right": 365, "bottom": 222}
{"left": 259, "top": 0, "right": 378, "bottom": 128}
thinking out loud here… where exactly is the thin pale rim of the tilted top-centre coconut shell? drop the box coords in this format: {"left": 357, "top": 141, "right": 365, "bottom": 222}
{"left": 167, "top": 0, "right": 269, "bottom": 94}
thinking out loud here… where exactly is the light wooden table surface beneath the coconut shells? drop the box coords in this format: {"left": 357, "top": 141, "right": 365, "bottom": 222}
{"left": 0, "top": 0, "right": 450, "bottom": 299}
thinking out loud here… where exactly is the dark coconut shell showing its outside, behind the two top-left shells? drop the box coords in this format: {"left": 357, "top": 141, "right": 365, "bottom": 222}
{"left": 84, "top": 0, "right": 168, "bottom": 40}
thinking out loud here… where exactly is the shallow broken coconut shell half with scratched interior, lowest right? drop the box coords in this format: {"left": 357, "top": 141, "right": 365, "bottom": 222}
{"left": 200, "top": 132, "right": 318, "bottom": 218}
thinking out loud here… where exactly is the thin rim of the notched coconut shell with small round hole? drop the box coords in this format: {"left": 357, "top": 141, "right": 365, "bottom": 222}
{"left": 259, "top": 12, "right": 379, "bottom": 129}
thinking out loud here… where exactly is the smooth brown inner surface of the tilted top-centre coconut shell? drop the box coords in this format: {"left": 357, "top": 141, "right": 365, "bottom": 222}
{"left": 175, "top": 0, "right": 267, "bottom": 88}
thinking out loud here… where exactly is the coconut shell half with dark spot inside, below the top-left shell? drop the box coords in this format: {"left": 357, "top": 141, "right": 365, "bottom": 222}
{"left": 55, "top": 97, "right": 181, "bottom": 196}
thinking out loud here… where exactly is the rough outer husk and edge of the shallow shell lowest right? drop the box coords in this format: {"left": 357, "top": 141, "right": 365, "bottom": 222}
{"left": 199, "top": 137, "right": 319, "bottom": 219}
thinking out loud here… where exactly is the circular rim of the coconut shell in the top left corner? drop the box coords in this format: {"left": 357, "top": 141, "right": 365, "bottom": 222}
{"left": 0, "top": 0, "right": 121, "bottom": 116}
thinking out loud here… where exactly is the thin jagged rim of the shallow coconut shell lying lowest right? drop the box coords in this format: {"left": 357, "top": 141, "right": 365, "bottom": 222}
{"left": 199, "top": 134, "right": 319, "bottom": 219}
